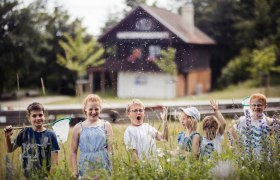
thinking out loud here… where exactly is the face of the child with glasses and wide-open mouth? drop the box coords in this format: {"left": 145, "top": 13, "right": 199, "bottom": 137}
{"left": 127, "top": 104, "right": 145, "bottom": 126}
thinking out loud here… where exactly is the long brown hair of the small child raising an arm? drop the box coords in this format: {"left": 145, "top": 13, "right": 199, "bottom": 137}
{"left": 202, "top": 116, "right": 219, "bottom": 140}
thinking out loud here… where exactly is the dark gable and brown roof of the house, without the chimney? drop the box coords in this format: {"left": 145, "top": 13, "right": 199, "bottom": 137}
{"left": 99, "top": 5, "right": 215, "bottom": 45}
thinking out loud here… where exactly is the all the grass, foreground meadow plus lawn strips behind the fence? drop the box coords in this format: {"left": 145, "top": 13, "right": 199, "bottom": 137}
{"left": 0, "top": 82, "right": 280, "bottom": 180}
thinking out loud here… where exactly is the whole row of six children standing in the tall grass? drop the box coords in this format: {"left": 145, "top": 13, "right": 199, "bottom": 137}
{"left": 4, "top": 93, "right": 278, "bottom": 178}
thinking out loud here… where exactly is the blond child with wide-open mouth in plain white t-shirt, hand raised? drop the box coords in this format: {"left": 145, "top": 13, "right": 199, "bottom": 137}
{"left": 124, "top": 99, "right": 168, "bottom": 163}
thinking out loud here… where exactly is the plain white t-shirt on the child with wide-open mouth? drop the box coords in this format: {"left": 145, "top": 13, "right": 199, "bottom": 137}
{"left": 124, "top": 123, "right": 158, "bottom": 160}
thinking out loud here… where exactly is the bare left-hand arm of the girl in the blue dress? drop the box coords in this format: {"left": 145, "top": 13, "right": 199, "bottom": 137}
{"left": 70, "top": 124, "right": 81, "bottom": 178}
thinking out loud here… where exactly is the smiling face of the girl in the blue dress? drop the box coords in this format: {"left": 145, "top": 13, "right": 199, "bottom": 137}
{"left": 84, "top": 101, "right": 101, "bottom": 120}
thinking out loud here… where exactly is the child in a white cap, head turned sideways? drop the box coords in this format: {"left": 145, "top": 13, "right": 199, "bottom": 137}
{"left": 177, "top": 107, "right": 202, "bottom": 158}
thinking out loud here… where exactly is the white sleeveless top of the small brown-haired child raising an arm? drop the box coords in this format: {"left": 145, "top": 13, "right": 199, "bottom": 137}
{"left": 200, "top": 133, "right": 224, "bottom": 157}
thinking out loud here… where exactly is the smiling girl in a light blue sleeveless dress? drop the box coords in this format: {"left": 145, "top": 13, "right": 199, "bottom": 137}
{"left": 70, "top": 94, "right": 113, "bottom": 178}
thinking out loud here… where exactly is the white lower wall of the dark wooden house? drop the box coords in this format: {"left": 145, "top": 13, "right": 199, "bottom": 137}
{"left": 117, "top": 72, "right": 176, "bottom": 99}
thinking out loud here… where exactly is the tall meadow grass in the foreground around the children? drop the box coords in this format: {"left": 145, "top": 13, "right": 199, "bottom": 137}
{"left": 0, "top": 116, "right": 280, "bottom": 179}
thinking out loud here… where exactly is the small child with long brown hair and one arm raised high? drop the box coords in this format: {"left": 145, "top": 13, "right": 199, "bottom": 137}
{"left": 200, "top": 100, "right": 226, "bottom": 158}
